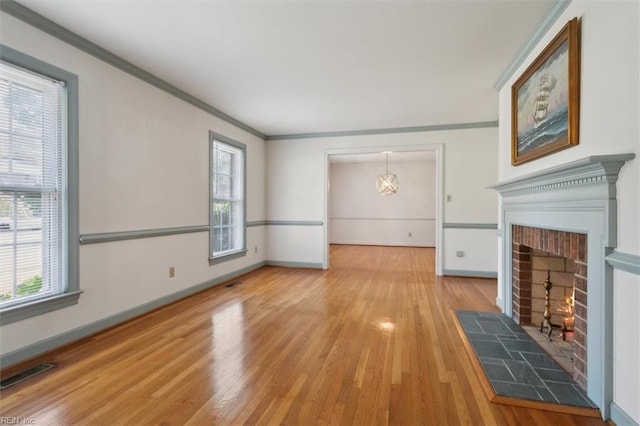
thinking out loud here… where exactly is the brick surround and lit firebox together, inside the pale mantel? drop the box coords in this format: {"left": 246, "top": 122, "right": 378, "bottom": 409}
{"left": 512, "top": 225, "right": 587, "bottom": 389}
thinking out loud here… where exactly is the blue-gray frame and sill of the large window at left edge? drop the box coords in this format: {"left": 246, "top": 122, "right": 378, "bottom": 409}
{"left": 0, "top": 44, "right": 82, "bottom": 325}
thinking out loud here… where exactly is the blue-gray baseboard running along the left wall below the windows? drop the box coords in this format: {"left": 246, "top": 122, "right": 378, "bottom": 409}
{"left": 0, "top": 262, "right": 266, "bottom": 368}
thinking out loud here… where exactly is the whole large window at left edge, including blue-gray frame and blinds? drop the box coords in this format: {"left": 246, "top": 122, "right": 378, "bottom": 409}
{"left": 0, "top": 46, "right": 80, "bottom": 324}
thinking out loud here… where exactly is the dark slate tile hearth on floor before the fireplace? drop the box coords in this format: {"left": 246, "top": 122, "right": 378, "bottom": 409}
{"left": 456, "top": 311, "right": 597, "bottom": 408}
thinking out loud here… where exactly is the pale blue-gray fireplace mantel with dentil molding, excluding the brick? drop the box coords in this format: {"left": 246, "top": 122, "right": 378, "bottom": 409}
{"left": 493, "top": 154, "right": 635, "bottom": 419}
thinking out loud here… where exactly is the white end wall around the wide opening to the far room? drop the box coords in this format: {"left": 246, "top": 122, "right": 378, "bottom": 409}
{"left": 267, "top": 127, "right": 498, "bottom": 272}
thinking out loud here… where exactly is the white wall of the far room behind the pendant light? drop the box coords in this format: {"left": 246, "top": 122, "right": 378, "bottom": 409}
{"left": 329, "top": 159, "right": 436, "bottom": 247}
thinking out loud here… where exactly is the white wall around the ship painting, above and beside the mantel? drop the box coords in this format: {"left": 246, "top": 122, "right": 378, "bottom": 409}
{"left": 498, "top": 1, "right": 640, "bottom": 423}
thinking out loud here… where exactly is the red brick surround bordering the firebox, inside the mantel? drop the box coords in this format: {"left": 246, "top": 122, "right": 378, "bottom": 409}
{"left": 511, "top": 225, "right": 587, "bottom": 390}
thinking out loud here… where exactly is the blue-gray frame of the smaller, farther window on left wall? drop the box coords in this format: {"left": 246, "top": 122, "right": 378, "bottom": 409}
{"left": 208, "top": 130, "right": 247, "bottom": 265}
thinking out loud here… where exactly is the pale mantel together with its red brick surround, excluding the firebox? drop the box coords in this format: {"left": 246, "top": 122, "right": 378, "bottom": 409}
{"left": 494, "top": 154, "right": 635, "bottom": 420}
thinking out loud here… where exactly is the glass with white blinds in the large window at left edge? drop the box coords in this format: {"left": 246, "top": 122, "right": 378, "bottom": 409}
{"left": 0, "top": 61, "right": 68, "bottom": 308}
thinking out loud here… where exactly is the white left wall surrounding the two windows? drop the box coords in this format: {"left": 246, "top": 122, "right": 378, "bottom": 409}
{"left": 0, "top": 13, "right": 266, "bottom": 354}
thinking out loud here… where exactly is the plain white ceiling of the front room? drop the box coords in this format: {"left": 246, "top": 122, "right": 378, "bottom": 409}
{"left": 19, "top": 0, "right": 553, "bottom": 136}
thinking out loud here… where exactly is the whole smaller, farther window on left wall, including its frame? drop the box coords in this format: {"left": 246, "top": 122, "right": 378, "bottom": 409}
{"left": 209, "top": 132, "right": 247, "bottom": 264}
